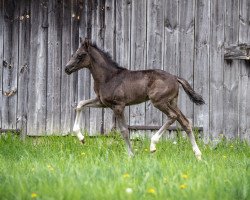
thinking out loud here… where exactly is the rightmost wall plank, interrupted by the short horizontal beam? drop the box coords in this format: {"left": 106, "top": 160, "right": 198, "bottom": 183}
{"left": 239, "top": 0, "right": 250, "bottom": 141}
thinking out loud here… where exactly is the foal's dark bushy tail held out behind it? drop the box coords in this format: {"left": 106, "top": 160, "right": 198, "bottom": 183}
{"left": 177, "top": 77, "right": 205, "bottom": 105}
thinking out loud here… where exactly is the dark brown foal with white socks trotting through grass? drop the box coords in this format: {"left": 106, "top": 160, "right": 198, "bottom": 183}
{"left": 65, "top": 39, "right": 204, "bottom": 159}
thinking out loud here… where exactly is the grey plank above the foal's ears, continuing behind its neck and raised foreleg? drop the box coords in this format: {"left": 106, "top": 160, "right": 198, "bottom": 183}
{"left": 88, "top": 0, "right": 102, "bottom": 135}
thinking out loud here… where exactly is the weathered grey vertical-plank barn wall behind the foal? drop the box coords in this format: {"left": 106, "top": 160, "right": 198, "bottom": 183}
{"left": 0, "top": 0, "right": 250, "bottom": 140}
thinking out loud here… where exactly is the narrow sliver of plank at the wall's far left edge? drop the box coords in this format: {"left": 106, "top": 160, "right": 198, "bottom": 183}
{"left": 0, "top": 1, "right": 4, "bottom": 127}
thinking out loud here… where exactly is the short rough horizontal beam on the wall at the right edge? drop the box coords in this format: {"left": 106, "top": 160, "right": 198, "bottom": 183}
{"left": 224, "top": 44, "right": 250, "bottom": 60}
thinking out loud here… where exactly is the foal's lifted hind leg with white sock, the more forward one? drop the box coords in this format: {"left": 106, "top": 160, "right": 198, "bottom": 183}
{"left": 150, "top": 103, "right": 177, "bottom": 153}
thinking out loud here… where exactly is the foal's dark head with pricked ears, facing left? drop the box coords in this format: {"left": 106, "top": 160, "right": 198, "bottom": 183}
{"left": 65, "top": 38, "right": 91, "bottom": 74}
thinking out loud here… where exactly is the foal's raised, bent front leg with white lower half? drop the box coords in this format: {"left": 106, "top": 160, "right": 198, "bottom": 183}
{"left": 73, "top": 98, "right": 103, "bottom": 143}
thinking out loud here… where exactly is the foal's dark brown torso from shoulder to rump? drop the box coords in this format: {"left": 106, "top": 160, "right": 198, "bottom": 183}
{"left": 101, "top": 70, "right": 178, "bottom": 105}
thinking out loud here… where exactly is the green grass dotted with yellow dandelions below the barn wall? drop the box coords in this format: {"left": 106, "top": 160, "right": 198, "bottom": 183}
{"left": 0, "top": 135, "right": 250, "bottom": 200}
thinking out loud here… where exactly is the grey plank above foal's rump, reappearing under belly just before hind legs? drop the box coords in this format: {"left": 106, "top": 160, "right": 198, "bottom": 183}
{"left": 146, "top": 0, "right": 164, "bottom": 137}
